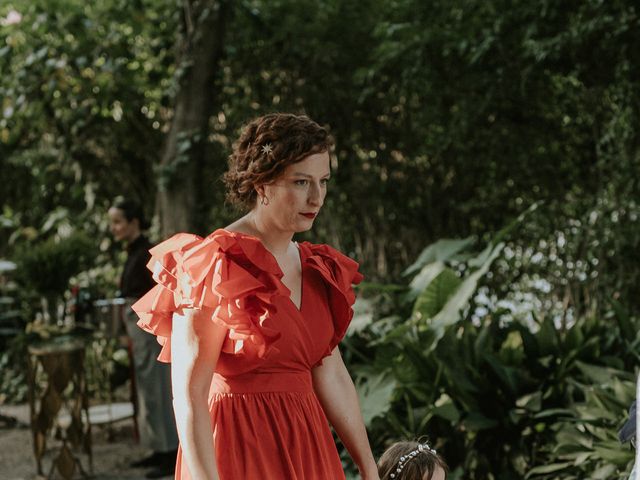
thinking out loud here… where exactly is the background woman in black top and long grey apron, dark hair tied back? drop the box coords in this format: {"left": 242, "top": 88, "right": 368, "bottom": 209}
{"left": 109, "top": 200, "right": 178, "bottom": 478}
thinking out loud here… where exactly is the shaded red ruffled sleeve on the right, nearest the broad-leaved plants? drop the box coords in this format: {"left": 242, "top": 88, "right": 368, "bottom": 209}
{"left": 302, "top": 242, "right": 364, "bottom": 365}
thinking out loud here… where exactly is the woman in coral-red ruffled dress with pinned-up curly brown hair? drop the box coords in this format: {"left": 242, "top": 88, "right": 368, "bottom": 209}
{"left": 133, "top": 114, "right": 378, "bottom": 480}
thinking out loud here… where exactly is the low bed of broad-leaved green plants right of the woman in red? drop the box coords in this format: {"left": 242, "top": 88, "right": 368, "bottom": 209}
{"left": 345, "top": 232, "right": 640, "bottom": 479}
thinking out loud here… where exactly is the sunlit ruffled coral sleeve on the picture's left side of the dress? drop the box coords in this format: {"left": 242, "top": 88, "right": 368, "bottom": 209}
{"left": 132, "top": 230, "right": 288, "bottom": 362}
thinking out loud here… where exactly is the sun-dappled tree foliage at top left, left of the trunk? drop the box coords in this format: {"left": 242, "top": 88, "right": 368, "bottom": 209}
{"left": 0, "top": 0, "right": 179, "bottom": 248}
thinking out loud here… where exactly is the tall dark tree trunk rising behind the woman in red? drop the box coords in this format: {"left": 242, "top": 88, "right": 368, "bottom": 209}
{"left": 157, "top": 0, "right": 231, "bottom": 238}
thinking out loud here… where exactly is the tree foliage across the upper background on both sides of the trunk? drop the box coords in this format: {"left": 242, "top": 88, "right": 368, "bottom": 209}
{"left": 0, "top": 0, "right": 640, "bottom": 309}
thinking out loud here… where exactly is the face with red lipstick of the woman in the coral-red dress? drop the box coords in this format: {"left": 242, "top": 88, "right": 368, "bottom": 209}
{"left": 256, "top": 152, "right": 331, "bottom": 232}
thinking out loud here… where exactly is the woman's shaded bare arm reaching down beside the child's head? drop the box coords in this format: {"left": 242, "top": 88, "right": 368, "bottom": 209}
{"left": 312, "top": 347, "right": 378, "bottom": 480}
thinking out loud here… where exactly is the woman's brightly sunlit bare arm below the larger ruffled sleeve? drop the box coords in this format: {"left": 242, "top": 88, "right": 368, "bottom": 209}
{"left": 171, "top": 309, "right": 227, "bottom": 480}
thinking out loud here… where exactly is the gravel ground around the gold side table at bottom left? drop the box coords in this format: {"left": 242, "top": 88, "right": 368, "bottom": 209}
{"left": 0, "top": 405, "right": 173, "bottom": 480}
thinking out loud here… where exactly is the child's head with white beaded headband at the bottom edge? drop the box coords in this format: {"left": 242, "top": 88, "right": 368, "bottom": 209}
{"left": 378, "top": 442, "right": 448, "bottom": 480}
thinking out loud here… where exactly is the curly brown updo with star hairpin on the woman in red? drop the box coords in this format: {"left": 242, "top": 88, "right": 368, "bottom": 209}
{"left": 223, "top": 113, "right": 333, "bottom": 210}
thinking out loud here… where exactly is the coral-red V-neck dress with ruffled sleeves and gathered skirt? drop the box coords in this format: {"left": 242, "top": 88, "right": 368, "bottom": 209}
{"left": 133, "top": 229, "right": 362, "bottom": 480}
